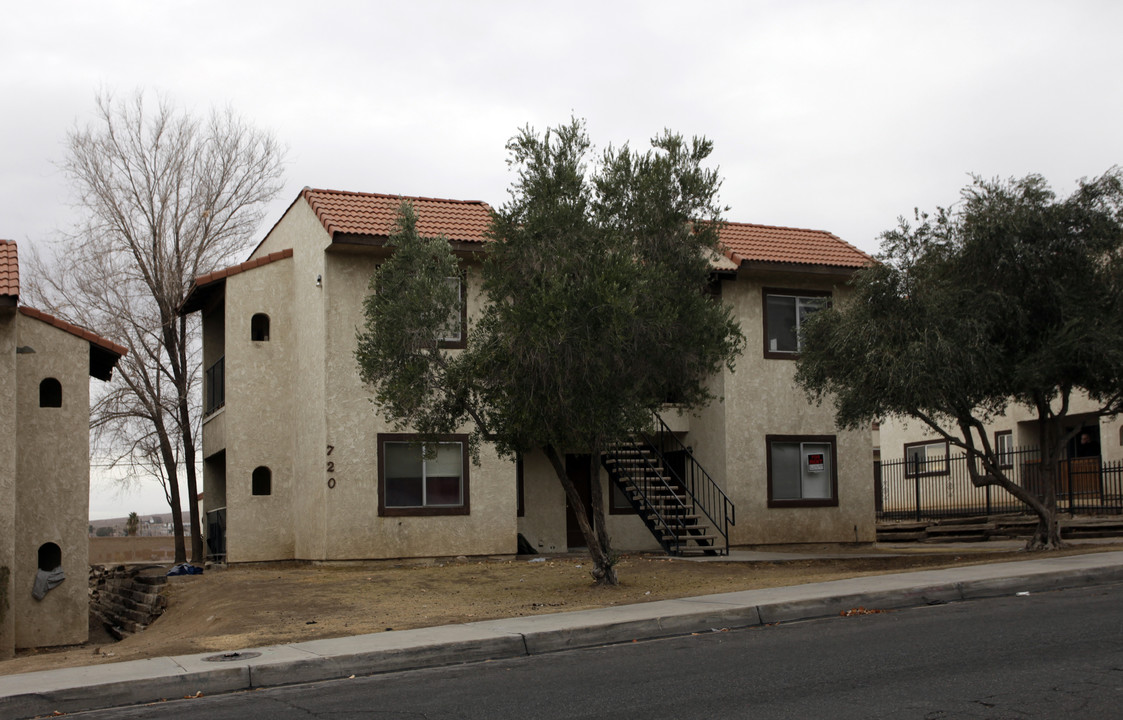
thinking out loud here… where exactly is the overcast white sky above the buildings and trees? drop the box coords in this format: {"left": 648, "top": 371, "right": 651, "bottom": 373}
{"left": 0, "top": 0, "right": 1123, "bottom": 517}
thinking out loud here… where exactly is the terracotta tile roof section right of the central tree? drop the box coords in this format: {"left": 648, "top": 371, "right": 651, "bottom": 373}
{"left": 719, "top": 222, "right": 874, "bottom": 267}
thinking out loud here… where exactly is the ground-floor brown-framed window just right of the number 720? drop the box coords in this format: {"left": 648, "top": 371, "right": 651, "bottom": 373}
{"left": 378, "top": 435, "right": 468, "bottom": 516}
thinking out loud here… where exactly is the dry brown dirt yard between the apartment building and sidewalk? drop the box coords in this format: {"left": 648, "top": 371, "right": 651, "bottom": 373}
{"left": 0, "top": 544, "right": 1123, "bottom": 675}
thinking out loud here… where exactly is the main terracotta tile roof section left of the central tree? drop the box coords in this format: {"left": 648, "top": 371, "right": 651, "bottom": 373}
{"left": 301, "top": 188, "right": 491, "bottom": 243}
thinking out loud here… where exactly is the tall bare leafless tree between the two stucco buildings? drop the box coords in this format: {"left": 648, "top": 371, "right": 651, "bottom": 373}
{"left": 29, "top": 91, "right": 285, "bottom": 562}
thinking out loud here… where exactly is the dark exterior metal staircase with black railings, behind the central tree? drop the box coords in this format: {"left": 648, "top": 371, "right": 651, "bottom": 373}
{"left": 601, "top": 413, "right": 736, "bottom": 555}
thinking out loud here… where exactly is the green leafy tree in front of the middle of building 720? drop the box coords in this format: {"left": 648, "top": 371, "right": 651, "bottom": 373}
{"left": 356, "top": 120, "right": 743, "bottom": 584}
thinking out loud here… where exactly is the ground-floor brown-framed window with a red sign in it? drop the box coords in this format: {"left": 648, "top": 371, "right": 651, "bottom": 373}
{"left": 765, "top": 435, "right": 839, "bottom": 508}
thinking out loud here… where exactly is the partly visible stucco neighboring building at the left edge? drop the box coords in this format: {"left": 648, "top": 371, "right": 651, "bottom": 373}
{"left": 0, "top": 240, "right": 126, "bottom": 657}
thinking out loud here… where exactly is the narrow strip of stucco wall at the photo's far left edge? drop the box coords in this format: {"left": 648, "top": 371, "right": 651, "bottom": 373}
{"left": 0, "top": 308, "right": 16, "bottom": 658}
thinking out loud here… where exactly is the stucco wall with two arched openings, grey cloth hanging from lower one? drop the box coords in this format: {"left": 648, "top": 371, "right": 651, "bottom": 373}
{"left": 13, "top": 316, "right": 90, "bottom": 647}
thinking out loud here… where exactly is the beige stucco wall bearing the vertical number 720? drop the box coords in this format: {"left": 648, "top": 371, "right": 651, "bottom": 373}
{"left": 204, "top": 201, "right": 517, "bottom": 563}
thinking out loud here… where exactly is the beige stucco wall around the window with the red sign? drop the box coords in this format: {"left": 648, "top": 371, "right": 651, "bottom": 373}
{"left": 686, "top": 271, "right": 875, "bottom": 545}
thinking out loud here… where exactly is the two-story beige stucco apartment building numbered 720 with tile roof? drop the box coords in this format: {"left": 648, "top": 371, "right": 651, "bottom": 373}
{"left": 183, "top": 189, "right": 874, "bottom": 562}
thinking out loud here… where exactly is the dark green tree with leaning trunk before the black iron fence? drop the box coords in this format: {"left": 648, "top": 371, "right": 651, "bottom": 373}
{"left": 796, "top": 168, "right": 1123, "bottom": 548}
